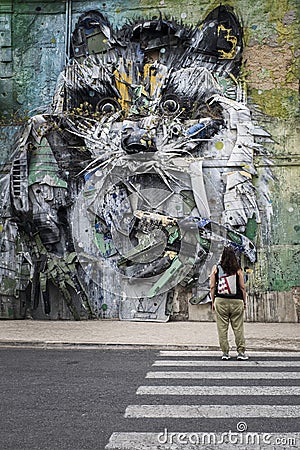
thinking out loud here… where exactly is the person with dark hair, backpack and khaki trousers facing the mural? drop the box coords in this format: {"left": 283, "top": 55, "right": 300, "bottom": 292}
{"left": 210, "top": 247, "right": 248, "bottom": 360}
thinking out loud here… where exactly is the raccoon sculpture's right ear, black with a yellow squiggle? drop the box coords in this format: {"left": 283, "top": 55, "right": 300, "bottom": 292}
{"left": 189, "top": 5, "right": 243, "bottom": 76}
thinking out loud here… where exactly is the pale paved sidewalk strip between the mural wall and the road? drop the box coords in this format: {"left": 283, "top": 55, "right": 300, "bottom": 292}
{"left": 0, "top": 320, "right": 300, "bottom": 351}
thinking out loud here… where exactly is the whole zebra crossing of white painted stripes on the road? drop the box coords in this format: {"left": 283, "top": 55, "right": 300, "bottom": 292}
{"left": 105, "top": 351, "right": 300, "bottom": 450}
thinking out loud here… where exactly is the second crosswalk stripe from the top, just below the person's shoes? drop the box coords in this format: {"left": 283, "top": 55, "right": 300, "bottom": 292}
{"left": 152, "top": 359, "right": 300, "bottom": 367}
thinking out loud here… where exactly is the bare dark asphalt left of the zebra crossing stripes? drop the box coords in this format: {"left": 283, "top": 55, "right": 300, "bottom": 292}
{"left": 0, "top": 349, "right": 155, "bottom": 450}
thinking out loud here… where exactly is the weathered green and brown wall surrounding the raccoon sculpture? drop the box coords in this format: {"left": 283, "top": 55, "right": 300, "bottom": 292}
{"left": 0, "top": 0, "right": 300, "bottom": 321}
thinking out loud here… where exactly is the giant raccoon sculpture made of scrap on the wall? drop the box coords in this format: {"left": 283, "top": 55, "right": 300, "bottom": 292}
{"left": 1, "top": 6, "right": 270, "bottom": 321}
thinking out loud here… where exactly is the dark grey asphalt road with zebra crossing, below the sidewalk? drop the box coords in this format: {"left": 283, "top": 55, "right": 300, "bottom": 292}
{"left": 0, "top": 348, "right": 300, "bottom": 450}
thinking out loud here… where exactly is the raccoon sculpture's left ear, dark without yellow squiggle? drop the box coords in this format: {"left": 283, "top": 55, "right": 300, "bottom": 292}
{"left": 71, "top": 11, "right": 116, "bottom": 58}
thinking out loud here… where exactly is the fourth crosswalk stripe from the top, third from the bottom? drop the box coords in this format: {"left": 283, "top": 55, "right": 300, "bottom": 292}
{"left": 136, "top": 386, "right": 300, "bottom": 396}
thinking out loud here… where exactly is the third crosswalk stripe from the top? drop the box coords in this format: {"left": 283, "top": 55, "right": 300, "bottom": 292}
{"left": 146, "top": 371, "right": 300, "bottom": 380}
